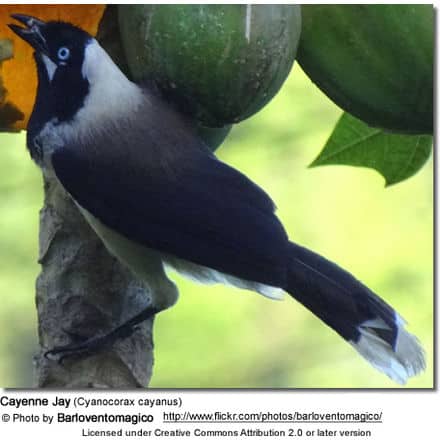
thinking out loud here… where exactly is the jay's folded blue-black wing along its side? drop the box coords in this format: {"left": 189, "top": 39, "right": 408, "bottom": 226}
{"left": 52, "top": 129, "right": 288, "bottom": 287}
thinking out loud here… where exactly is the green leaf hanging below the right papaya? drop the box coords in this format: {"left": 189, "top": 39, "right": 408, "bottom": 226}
{"left": 310, "top": 113, "right": 432, "bottom": 186}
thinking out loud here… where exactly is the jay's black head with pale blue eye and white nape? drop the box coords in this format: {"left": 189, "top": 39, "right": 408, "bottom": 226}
{"left": 9, "top": 14, "right": 139, "bottom": 126}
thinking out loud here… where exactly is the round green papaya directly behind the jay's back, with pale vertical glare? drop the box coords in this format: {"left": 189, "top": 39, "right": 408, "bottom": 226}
{"left": 119, "top": 4, "right": 301, "bottom": 127}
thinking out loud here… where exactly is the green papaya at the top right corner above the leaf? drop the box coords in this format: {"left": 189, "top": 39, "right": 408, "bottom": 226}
{"left": 297, "top": 4, "right": 434, "bottom": 134}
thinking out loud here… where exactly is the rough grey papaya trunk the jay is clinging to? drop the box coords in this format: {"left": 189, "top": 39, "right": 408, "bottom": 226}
{"left": 35, "top": 7, "right": 153, "bottom": 388}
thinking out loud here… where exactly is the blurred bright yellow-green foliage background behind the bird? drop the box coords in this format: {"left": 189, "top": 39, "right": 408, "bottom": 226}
{"left": 0, "top": 65, "right": 433, "bottom": 388}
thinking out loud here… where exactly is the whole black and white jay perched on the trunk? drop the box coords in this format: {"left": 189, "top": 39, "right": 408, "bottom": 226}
{"left": 10, "top": 14, "right": 425, "bottom": 384}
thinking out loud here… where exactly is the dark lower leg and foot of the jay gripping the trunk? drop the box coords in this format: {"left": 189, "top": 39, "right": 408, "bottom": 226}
{"left": 44, "top": 307, "right": 160, "bottom": 363}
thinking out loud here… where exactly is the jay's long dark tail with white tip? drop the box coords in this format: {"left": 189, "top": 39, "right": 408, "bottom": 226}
{"left": 286, "top": 243, "right": 425, "bottom": 384}
